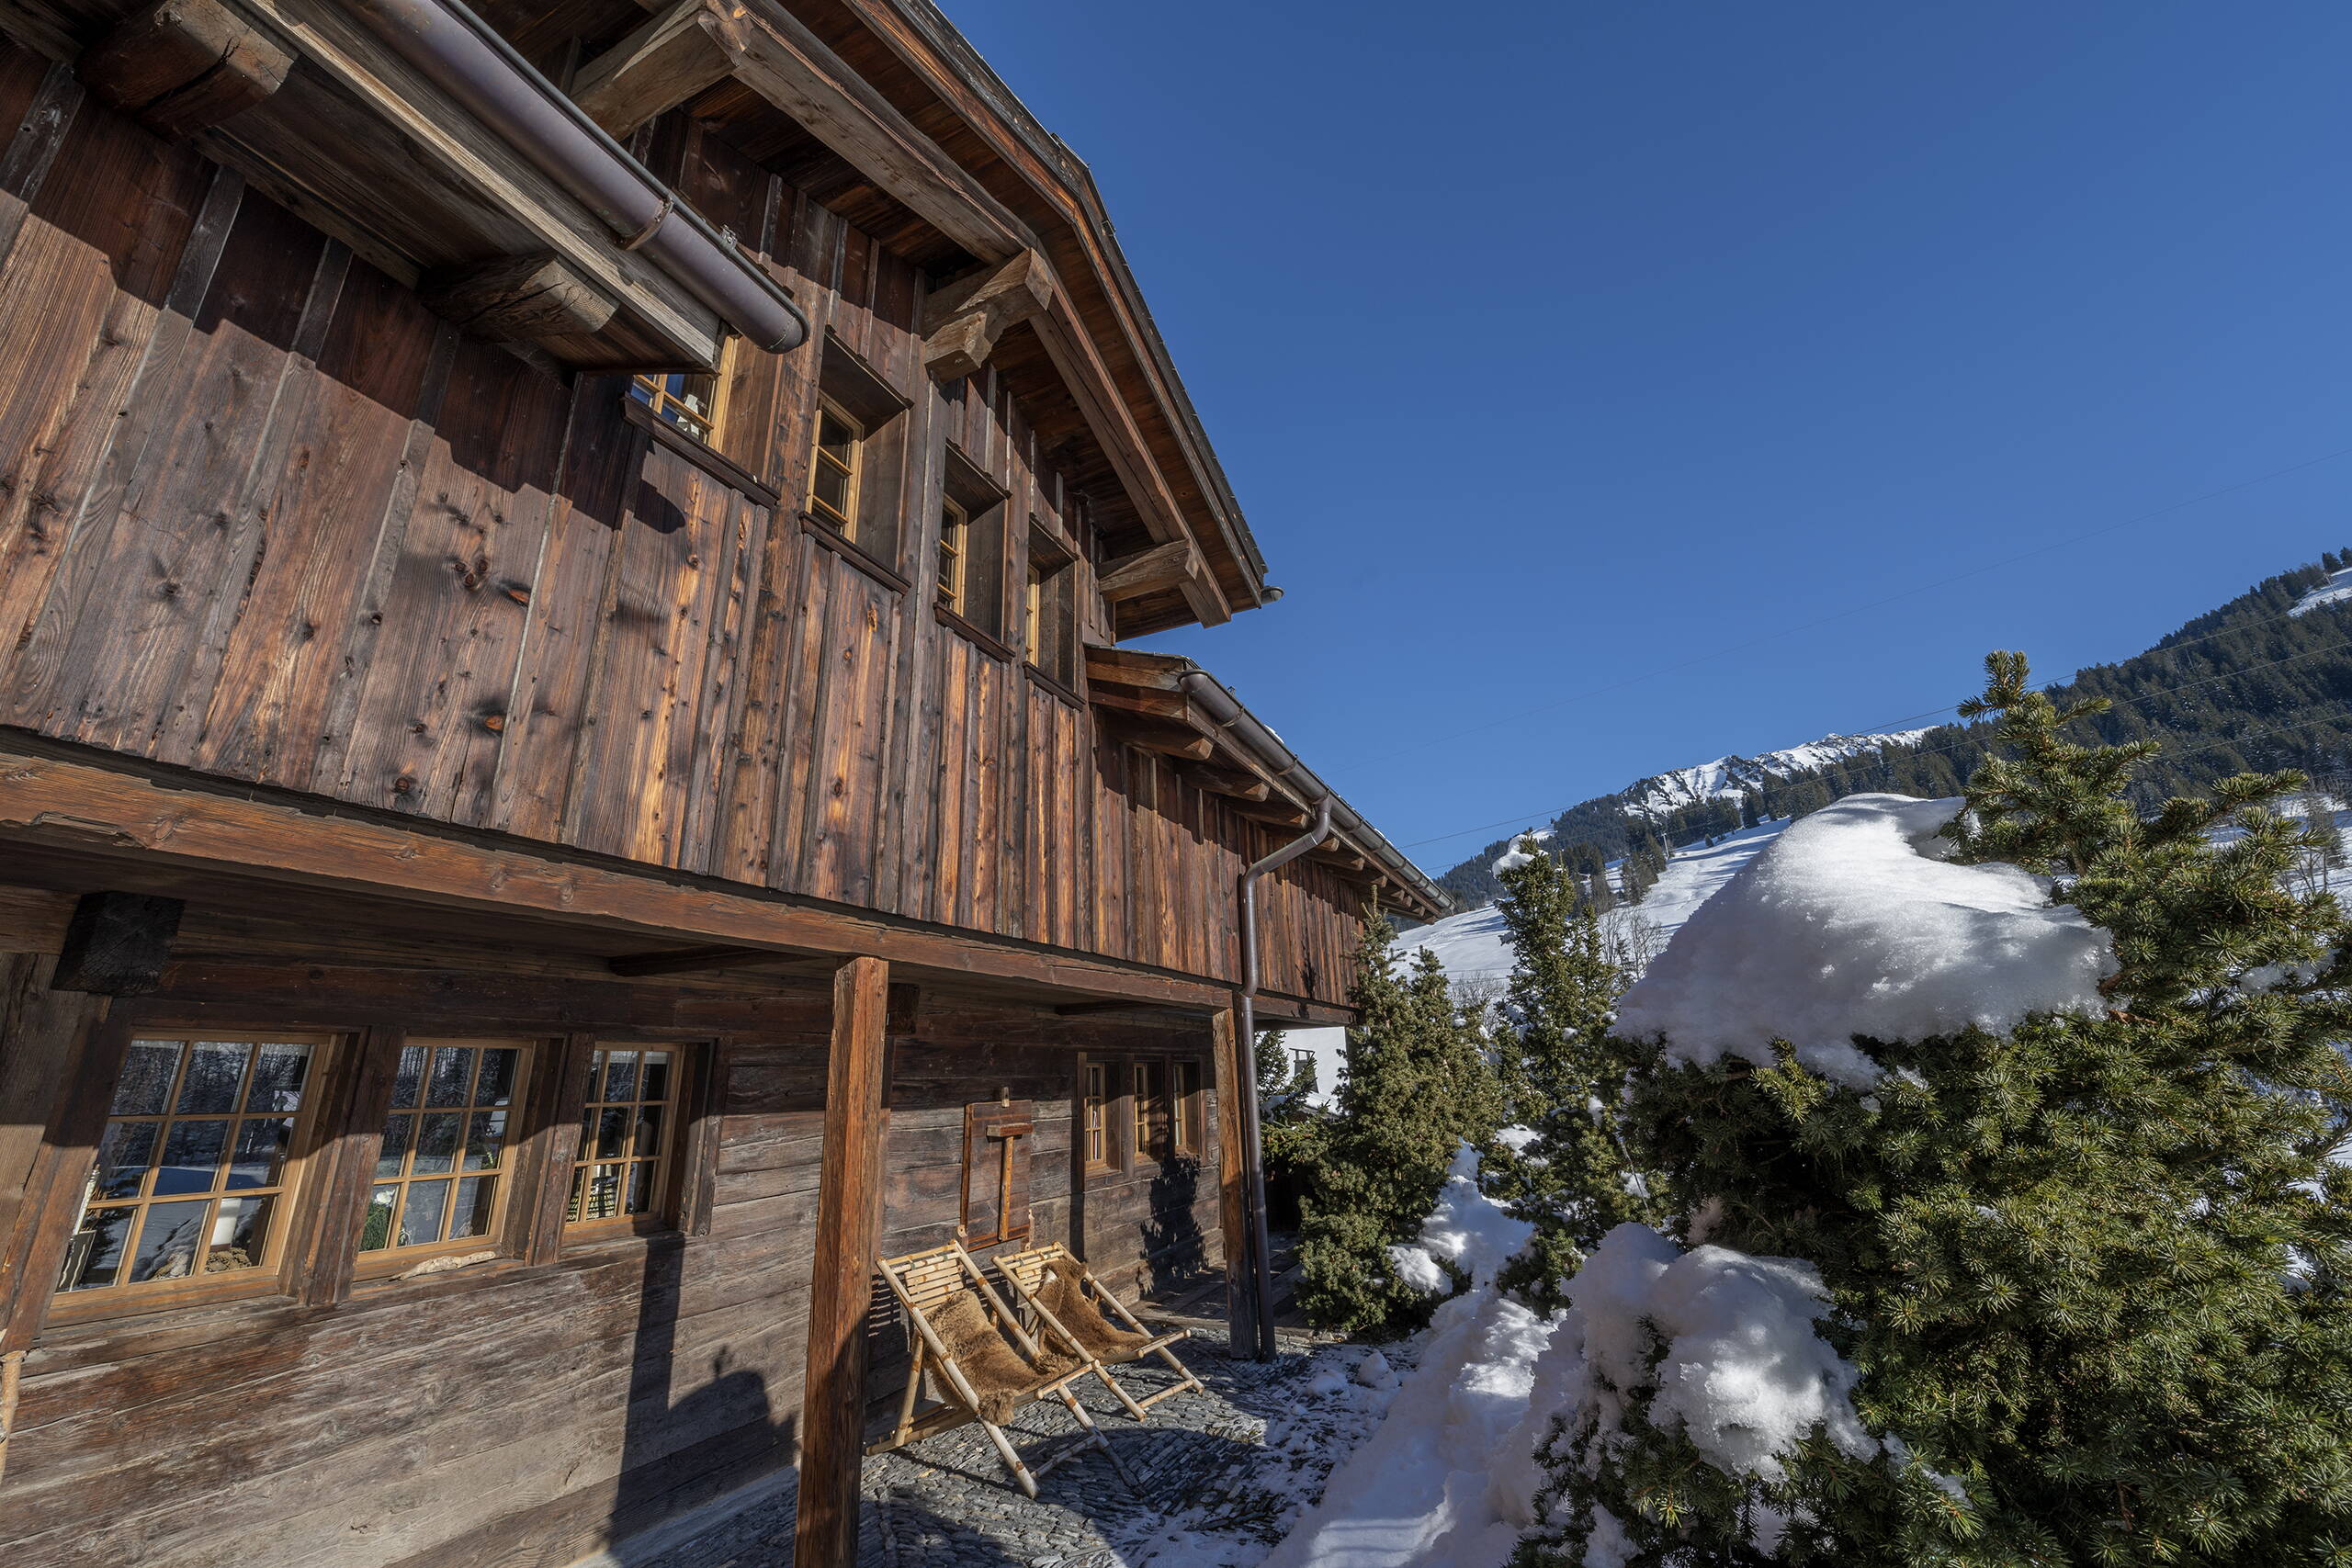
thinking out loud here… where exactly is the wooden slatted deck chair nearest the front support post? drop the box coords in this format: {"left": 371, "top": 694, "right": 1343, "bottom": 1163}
{"left": 865, "top": 1241, "right": 1134, "bottom": 1497}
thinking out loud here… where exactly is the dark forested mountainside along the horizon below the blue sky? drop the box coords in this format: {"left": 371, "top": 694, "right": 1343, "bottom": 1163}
{"left": 1440, "top": 550, "right": 2352, "bottom": 905}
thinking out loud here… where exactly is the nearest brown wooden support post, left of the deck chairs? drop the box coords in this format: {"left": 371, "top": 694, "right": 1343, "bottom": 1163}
{"left": 793, "top": 959, "right": 889, "bottom": 1568}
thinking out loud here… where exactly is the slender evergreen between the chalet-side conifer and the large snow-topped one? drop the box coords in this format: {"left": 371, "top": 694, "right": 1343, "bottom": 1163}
{"left": 1484, "top": 849, "right": 1654, "bottom": 1307}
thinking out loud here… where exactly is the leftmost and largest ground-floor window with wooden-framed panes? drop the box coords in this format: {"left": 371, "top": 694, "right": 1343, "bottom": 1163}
{"left": 56, "top": 1030, "right": 332, "bottom": 1300}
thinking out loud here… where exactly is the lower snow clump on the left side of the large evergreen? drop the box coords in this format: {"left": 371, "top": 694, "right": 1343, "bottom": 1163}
{"left": 1553, "top": 1223, "right": 1879, "bottom": 1481}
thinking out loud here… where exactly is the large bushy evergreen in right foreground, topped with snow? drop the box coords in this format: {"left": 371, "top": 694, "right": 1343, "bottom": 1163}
{"left": 1521, "top": 653, "right": 2352, "bottom": 1568}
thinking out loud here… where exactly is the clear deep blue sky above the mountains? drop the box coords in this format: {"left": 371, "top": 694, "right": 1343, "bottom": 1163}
{"left": 945, "top": 0, "right": 2352, "bottom": 870}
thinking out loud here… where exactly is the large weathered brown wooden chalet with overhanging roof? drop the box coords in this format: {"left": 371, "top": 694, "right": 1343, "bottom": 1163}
{"left": 0, "top": 0, "right": 1442, "bottom": 1568}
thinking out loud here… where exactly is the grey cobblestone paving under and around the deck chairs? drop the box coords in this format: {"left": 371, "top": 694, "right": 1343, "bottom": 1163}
{"left": 642, "top": 1337, "right": 1411, "bottom": 1568}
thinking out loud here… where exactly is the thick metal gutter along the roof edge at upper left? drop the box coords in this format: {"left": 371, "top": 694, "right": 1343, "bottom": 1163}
{"left": 344, "top": 0, "right": 809, "bottom": 353}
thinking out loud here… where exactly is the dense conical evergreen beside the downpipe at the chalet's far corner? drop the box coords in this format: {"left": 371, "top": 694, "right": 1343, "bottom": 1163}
{"left": 1298, "top": 915, "right": 1503, "bottom": 1333}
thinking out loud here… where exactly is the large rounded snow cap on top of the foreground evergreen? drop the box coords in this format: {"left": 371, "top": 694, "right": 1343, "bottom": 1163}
{"left": 1618, "top": 795, "right": 2117, "bottom": 1089}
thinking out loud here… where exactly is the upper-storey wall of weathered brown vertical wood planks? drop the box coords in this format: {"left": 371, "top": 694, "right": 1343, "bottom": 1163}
{"left": 0, "top": 61, "right": 1360, "bottom": 1001}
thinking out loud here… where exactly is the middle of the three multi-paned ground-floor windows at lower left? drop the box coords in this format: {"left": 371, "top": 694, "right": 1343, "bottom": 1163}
{"left": 360, "top": 1039, "right": 532, "bottom": 1267}
